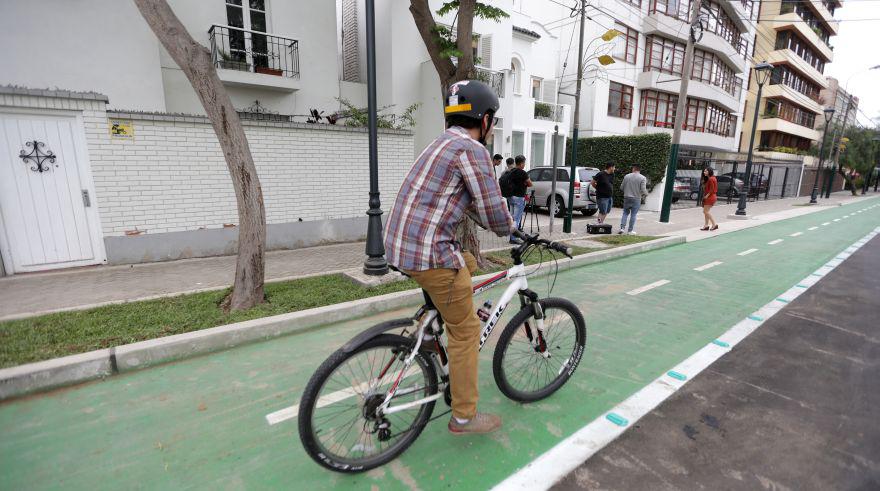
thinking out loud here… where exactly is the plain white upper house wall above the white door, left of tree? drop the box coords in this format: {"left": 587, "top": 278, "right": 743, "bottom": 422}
{"left": 0, "top": 0, "right": 165, "bottom": 111}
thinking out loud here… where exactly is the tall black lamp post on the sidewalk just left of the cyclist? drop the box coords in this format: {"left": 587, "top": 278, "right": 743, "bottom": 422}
{"left": 364, "top": 0, "right": 388, "bottom": 276}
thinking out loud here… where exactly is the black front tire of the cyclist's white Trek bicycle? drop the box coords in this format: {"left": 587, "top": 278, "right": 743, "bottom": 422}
{"left": 492, "top": 298, "right": 587, "bottom": 402}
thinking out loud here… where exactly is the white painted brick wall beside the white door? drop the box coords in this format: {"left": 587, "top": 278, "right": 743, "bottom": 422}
{"left": 86, "top": 112, "right": 413, "bottom": 240}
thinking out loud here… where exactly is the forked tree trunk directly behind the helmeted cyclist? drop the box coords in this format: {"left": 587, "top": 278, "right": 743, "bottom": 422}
{"left": 409, "top": 0, "right": 490, "bottom": 269}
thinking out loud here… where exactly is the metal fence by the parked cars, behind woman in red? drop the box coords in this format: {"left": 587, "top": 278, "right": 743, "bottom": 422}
{"left": 672, "top": 158, "right": 802, "bottom": 208}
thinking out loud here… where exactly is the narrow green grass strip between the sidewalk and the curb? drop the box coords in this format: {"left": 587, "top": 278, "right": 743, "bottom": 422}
{"left": 0, "top": 240, "right": 647, "bottom": 368}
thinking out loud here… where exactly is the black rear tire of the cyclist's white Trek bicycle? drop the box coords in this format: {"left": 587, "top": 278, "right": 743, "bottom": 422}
{"left": 298, "top": 334, "right": 438, "bottom": 474}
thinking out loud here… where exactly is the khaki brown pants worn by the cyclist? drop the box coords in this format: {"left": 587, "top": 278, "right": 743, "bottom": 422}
{"left": 406, "top": 252, "right": 480, "bottom": 419}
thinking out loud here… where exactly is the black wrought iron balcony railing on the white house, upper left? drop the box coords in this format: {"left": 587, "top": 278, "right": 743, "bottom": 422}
{"left": 208, "top": 25, "right": 299, "bottom": 78}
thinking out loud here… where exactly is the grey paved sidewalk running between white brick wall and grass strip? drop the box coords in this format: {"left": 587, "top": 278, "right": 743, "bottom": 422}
{"left": 0, "top": 192, "right": 876, "bottom": 321}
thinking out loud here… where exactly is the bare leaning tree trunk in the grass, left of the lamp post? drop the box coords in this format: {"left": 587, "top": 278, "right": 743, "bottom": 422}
{"left": 134, "top": 0, "right": 266, "bottom": 310}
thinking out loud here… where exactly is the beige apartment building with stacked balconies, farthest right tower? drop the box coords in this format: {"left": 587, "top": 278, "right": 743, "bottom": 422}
{"left": 740, "top": 0, "right": 841, "bottom": 158}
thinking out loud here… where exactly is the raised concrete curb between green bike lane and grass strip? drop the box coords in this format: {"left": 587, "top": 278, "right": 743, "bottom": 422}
{"left": 0, "top": 236, "right": 685, "bottom": 401}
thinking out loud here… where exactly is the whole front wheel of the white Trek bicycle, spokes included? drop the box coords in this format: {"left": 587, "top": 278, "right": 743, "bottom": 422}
{"left": 492, "top": 298, "right": 587, "bottom": 402}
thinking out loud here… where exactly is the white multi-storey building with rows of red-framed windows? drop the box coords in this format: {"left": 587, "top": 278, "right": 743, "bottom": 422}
{"left": 546, "top": 0, "right": 758, "bottom": 209}
